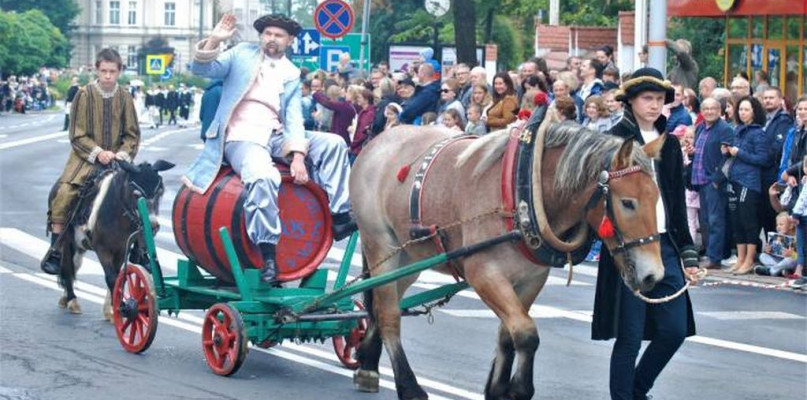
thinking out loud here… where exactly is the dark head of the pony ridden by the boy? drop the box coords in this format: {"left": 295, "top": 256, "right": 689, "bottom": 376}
{"left": 119, "top": 160, "right": 174, "bottom": 233}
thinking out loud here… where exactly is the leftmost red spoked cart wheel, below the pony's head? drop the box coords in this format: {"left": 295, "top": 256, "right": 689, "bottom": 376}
{"left": 112, "top": 263, "right": 159, "bottom": 353}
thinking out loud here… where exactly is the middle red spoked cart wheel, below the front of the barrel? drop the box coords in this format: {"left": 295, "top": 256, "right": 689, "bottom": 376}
{"left": 202, "top": 303, "right": 247, "bottom": 376}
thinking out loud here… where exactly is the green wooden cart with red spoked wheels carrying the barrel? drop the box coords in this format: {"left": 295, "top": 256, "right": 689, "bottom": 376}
{"left": 112, "top": 199, "right": 476, "bottom": 376}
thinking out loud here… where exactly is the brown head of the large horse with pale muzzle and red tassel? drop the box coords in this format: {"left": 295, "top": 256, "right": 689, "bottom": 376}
{"left": 589, "top": 136, "right": 665, "bottom": 291}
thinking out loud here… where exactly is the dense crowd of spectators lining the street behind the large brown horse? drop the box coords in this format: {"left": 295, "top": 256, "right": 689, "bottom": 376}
{"left": 280, "top": 40, "right": 807, "bottom": 287}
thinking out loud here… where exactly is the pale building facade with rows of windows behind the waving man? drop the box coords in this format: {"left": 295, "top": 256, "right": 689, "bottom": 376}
{"left": 70, "top": 0, "right": 215, "bottom": 71}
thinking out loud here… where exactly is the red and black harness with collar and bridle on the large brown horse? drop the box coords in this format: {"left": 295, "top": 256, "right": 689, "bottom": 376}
{"left": 404, "top": 124, "right": 661, "bottom": 272}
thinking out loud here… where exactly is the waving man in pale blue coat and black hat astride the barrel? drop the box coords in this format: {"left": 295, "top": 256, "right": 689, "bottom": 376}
{"left": 189, "top": 14, "right": 356, "bottom": 285}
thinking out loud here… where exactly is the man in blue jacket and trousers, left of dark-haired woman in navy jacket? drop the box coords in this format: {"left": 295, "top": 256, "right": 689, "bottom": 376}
{"left": 692, "top": 97, "right": 734, "bottom": 269}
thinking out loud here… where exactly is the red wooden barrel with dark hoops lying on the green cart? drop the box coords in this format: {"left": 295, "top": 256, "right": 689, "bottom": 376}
{"left": 172, "top": 167, "right": 333, "bottom": 283}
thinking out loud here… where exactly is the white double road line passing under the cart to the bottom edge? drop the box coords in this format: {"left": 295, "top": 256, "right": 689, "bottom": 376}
{"left": 7, "top": 273, "right": 468, "bottom": 400}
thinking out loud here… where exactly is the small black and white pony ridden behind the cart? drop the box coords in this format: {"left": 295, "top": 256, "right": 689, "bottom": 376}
{"left": 58, "top": 160, "right": 174, "bottom": 321}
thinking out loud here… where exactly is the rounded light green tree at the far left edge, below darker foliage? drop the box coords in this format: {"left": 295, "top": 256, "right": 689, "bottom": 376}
{"left": 0, "top": 10, "right": 69, "bottom": 74}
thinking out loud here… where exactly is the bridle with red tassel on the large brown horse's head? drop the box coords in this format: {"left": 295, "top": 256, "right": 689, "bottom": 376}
{"left": 586, "top": 165, "right": 661, "bottom": 280}
